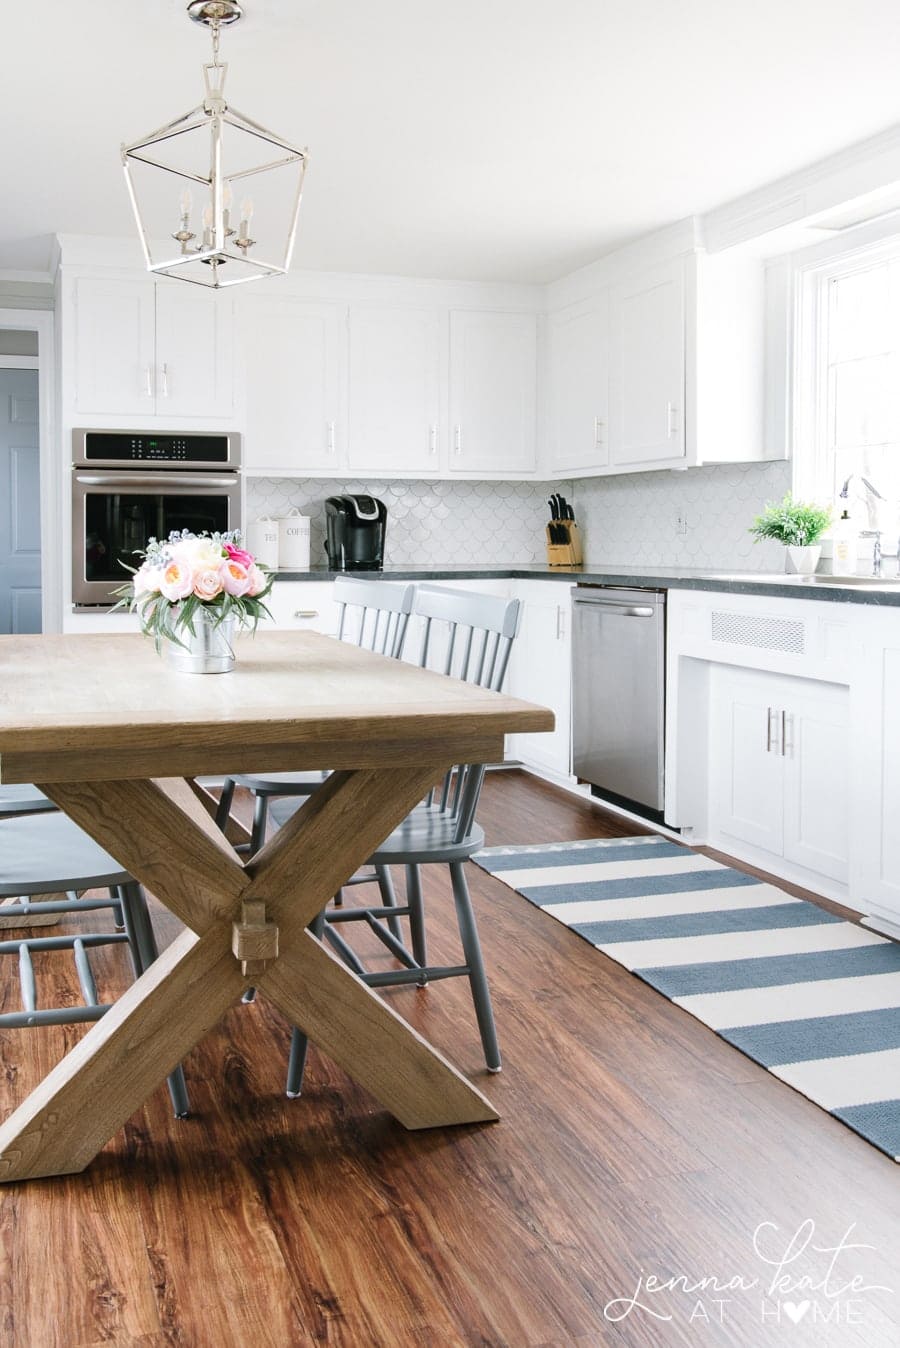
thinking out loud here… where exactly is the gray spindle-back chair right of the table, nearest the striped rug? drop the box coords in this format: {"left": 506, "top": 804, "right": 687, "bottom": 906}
{"left": 271, "top": 585, "right": 521, "bottom": 1097}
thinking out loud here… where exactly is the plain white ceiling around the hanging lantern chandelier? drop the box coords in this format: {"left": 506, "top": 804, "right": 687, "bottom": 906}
{"left": 0, "top": 0, "right": 900, "bottom": 282}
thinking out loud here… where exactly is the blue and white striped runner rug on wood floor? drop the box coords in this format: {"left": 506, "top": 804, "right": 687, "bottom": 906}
{"left": 474, "top": 837, "right": 900, "bottom": 1161}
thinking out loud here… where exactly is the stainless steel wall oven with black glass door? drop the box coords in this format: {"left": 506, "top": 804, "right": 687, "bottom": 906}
{"left": 71, "top": 430, "right": 241, "bottom": 609}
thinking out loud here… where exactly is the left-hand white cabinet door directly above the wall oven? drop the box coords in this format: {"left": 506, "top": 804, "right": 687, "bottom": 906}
{"left": 74, "top": 276, "right": 156, "bottom": 417}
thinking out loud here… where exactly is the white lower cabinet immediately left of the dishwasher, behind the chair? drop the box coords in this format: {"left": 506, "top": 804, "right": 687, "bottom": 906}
{"left": 507, "top": 581, "right": 571, "bottom": 778}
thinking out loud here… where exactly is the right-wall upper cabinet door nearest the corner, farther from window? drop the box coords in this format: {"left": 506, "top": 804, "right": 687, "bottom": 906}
{"left": 548, "top": 293, "right": 609, "bottom": 473}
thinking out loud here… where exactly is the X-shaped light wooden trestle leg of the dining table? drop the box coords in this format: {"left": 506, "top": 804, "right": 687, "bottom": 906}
{"left": 0, "top": 763, "right": 497, "bottom": 1181}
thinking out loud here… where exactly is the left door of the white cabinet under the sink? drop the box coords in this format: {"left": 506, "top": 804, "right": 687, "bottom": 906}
{"left": 710, "top": 666, "right": 784, "bottom": 856}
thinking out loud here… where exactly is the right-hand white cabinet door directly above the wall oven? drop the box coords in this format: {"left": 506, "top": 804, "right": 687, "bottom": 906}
{"left": 156, "top": 280, "right": 234, "bottom": 419}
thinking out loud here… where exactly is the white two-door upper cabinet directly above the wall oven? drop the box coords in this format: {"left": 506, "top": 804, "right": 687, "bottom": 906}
{"left": 73, "top": 276, "right": 234, "bottom": 422}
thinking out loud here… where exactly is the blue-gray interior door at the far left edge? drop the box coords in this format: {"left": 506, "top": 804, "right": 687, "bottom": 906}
{"left": 0, "top": 369, "right": 40, "bottom": 632}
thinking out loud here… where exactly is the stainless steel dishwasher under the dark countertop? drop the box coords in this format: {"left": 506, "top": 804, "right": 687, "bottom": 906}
{"left": 573, "top": 585, "right": 666, "bottom": 820}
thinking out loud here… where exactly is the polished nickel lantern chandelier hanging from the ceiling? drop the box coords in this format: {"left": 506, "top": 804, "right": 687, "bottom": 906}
{"left": 121, "top": 0, "right": 309, "bottom": 288}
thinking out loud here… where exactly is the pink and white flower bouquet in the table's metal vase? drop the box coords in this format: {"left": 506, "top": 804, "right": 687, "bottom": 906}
{"left": 113, "top": 530, "right": 275, "bottom": 650}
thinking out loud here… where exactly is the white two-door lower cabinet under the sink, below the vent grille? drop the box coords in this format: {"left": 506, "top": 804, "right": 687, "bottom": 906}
{"left": 709, "top": 665, "right": 850, "bottom": 883}
